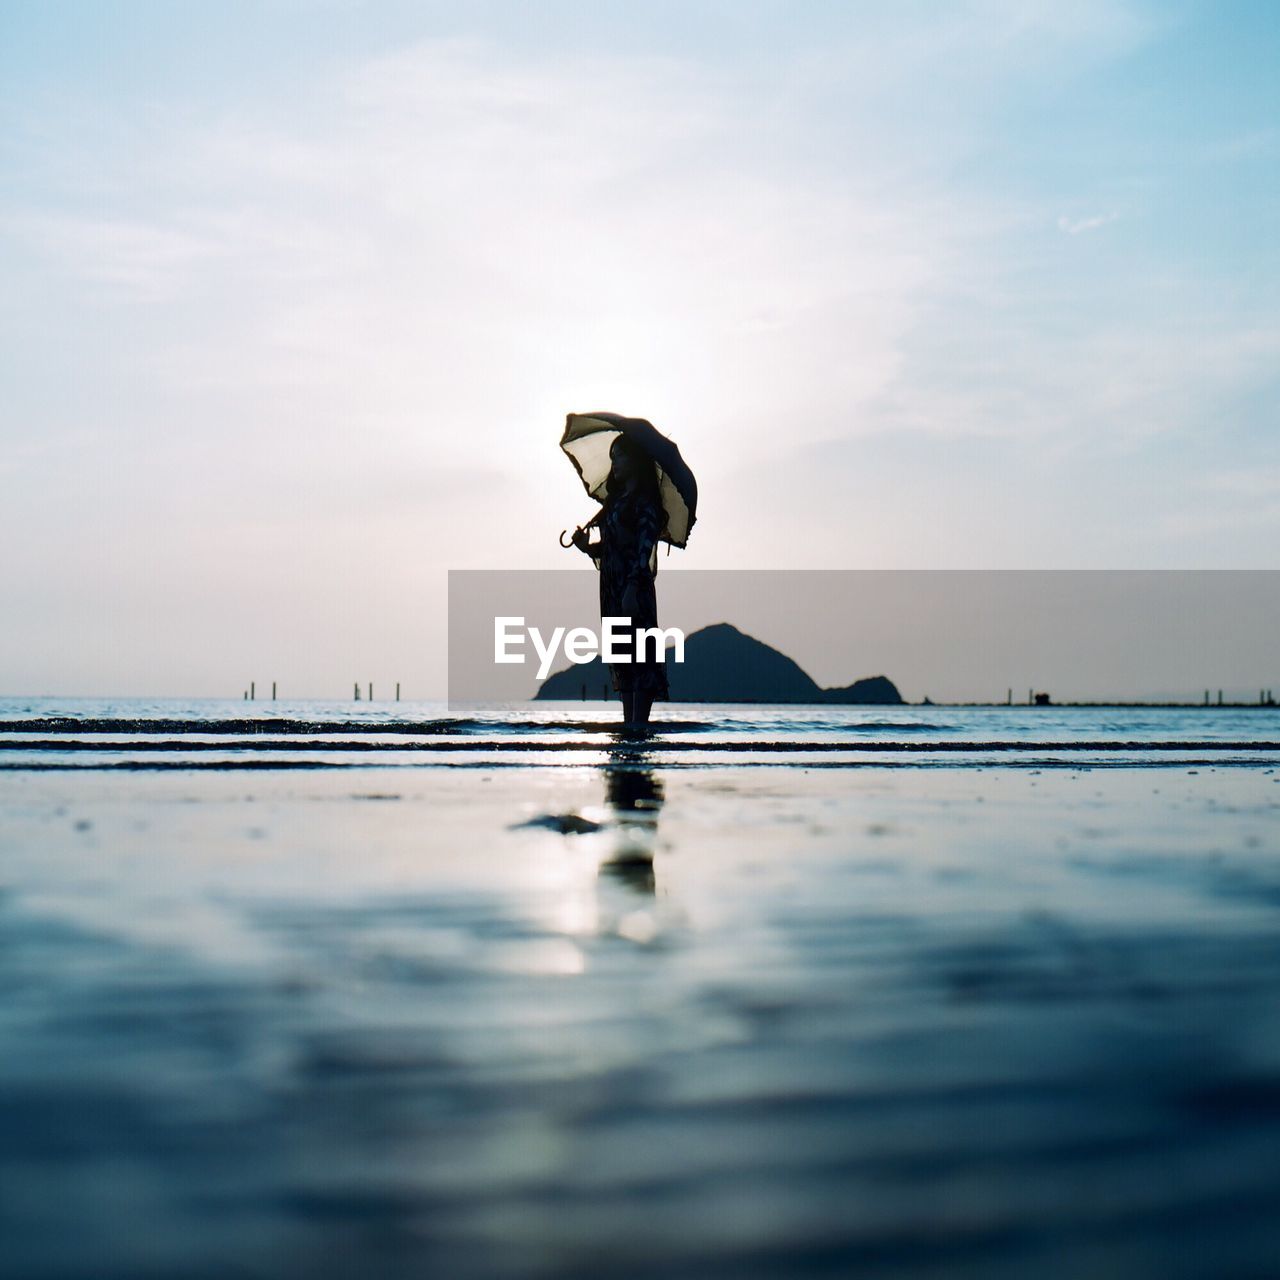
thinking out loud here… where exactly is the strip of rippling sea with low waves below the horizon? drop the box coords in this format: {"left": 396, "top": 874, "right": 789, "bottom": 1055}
{"left": 0, "top": 698, "right": 1280, "bottom": 769}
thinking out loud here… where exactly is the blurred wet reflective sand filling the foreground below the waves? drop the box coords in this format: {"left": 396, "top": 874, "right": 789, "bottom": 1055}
{"left": 0, "top": 754, "right": 1280, "bottom": 1280}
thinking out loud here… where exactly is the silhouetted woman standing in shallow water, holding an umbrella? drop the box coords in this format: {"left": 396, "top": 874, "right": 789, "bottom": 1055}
{"left": 573, "top": 435, "right": 671, "bottom": 728}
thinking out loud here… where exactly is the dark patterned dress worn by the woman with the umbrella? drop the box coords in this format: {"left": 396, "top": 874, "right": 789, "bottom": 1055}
{"left": 591, "top": 483, "right": 671, "bottom": 701}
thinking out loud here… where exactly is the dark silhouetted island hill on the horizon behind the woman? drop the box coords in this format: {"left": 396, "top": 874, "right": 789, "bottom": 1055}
{"left": 534, "top": 622, "right": 902, "bottom": 707}
